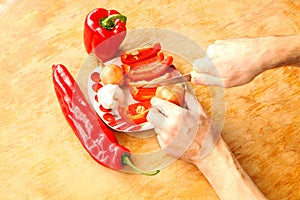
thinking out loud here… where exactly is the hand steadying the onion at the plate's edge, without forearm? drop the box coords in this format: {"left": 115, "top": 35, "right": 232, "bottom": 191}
{"left": 147, "top": 92, "right": 211, "bottom": 164}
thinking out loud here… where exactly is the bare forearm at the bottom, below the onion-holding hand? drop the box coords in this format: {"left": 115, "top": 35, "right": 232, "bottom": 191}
{"left": 196, "top": 138, "right": 265, "bottom": 200}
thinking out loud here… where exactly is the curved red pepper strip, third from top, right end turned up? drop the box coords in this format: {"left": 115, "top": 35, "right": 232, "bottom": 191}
{"left": 127, "top": 56, "right": 173, "bottom": 81}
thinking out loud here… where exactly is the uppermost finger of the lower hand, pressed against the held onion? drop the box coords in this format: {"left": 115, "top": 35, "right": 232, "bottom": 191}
{"left": 150, "top": 97, "right": 180, "bottom": 116}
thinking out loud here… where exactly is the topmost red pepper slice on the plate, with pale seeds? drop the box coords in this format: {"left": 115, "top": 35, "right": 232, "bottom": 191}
{"left": 121, "top": 43, "right": 161, "bottom": 65}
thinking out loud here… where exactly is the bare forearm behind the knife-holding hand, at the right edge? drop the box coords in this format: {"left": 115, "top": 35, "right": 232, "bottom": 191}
{"left": 265, "top": 34, "right": 300, "bottom": 70}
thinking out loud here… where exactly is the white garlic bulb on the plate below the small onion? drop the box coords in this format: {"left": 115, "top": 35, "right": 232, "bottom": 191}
{"left": 97, "top": 84, "right": 125, "bottom": 110}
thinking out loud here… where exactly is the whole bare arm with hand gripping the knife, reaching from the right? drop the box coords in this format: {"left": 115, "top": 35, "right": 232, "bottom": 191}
{"left": 192, "top": 34, "right": 300, "bottom": 88}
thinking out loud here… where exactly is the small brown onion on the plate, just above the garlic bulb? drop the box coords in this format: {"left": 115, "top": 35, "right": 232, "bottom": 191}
{"left": 100, "top": 64, "right": 124, "bottom": 85}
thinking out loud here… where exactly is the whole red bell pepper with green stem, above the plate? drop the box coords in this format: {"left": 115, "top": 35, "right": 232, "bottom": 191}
{"left": 84, "top": 8, "right": 127, "bottom": 62}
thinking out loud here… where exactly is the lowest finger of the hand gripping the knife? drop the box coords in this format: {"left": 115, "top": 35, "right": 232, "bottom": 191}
{"left": 191, "top": 74, "right": 224, "bottom": 87}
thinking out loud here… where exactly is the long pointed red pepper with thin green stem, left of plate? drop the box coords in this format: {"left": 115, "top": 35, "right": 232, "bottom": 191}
{"left": 52, "top": 64, "right": 159, "bottom": 175}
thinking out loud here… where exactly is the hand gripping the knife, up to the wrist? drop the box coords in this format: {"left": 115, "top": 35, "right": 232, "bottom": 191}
{"left": 192, "top": 37, "right": 272, "bottom": 88}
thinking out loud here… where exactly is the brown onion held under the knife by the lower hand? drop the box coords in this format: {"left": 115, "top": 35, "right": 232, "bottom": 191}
{"left": 155, "top": 83, "right": 185, "bottom": 106}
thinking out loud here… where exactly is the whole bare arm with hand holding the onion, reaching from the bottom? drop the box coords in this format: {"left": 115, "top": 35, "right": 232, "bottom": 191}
{"left": 147, "top": 93, "right": 265, "bottom": 200}
